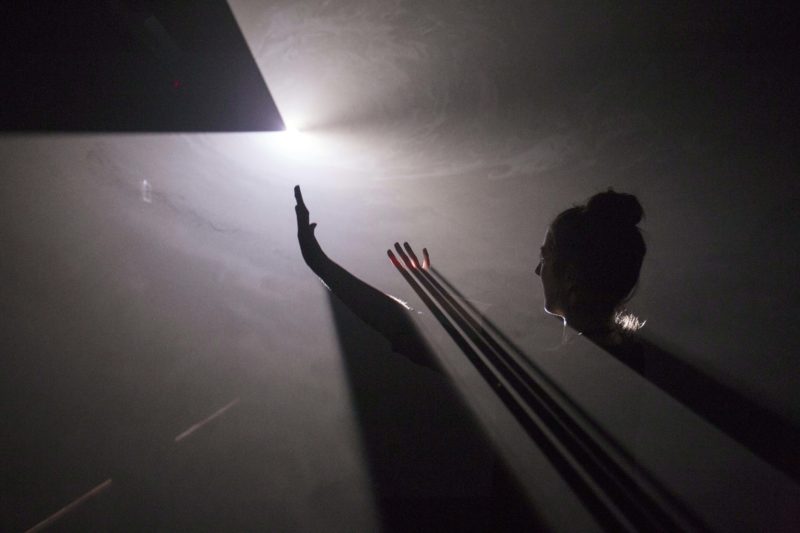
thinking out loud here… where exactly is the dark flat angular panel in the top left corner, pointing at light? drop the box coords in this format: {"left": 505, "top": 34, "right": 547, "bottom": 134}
{"left": 0, "top": 0, "right": 284, "bottom": 132}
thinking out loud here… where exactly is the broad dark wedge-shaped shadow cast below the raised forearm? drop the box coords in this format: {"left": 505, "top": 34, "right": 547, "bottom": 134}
{"left": 328, "top": 293, "right": 536, "bottom": 531}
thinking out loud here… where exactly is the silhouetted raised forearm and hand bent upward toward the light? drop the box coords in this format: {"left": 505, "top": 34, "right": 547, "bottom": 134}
{"left": 294, "top": 185, "right": 438, "bottom": 370}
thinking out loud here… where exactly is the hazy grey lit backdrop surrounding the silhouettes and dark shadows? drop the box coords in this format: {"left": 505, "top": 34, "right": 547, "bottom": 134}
{"left": 0, "top": 0, "right": 800, "bottom": 531}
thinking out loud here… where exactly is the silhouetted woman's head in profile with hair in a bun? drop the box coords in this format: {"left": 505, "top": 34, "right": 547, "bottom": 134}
{"left": 536, "top": 189, "right": 646, "bottom": 328}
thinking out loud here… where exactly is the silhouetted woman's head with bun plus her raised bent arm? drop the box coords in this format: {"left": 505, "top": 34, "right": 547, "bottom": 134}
{"left": 294, "top": 186, "right": 646, "bottom": 368}
